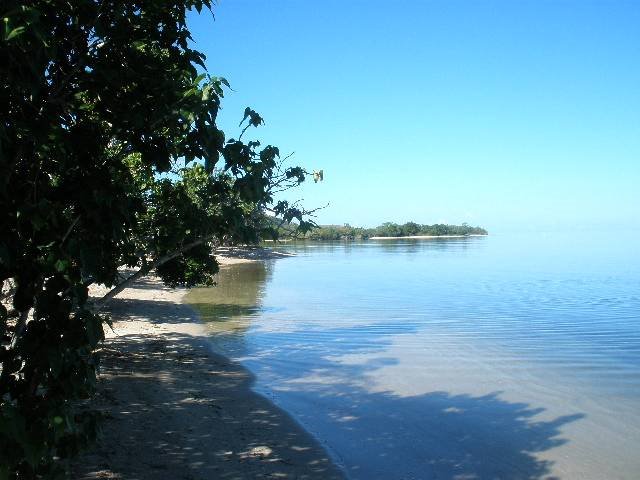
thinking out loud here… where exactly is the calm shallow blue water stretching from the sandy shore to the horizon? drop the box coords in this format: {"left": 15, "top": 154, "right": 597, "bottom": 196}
{"left": 189, "top": 234, "right": 640, "bottom": 480}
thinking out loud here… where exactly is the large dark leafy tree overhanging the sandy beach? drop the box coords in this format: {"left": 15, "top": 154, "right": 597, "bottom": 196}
{"left": 0, "top": 0, "right": 313, "bottom": 479}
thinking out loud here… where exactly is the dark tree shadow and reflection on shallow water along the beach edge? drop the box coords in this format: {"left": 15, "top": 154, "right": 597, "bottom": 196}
{"left": 189, "top": 278, "right": 583, "bottom": 480}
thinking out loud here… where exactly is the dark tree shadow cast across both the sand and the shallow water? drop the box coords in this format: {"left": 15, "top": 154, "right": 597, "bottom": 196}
{"left": 74, "top": 299, "right": 583, "bottom": 480}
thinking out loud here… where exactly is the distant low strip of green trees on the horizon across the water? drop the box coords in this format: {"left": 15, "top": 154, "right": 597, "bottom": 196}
{"left": 282, "top": 222, "right": 487, "bottom": 240}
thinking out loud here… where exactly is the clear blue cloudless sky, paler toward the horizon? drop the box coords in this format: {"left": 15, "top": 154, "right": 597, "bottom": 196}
{"left": 190, "top": 0, "right": 640, "bottom": 232}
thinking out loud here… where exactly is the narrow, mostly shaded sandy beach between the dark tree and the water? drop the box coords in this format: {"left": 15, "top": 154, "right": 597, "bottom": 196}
{"left": 72, "top": 249, "right": 343, "bottom": 480}
